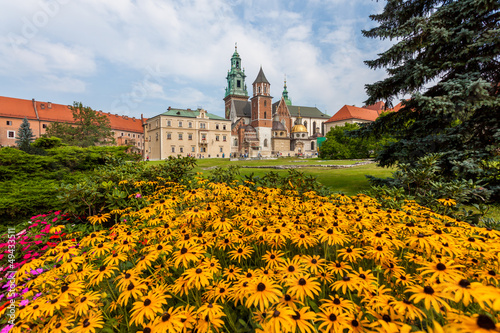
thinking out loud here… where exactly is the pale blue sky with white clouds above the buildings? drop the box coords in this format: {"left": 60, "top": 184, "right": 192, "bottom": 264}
{"left": 0, "top": 0, "right": 390, "bottom": 117}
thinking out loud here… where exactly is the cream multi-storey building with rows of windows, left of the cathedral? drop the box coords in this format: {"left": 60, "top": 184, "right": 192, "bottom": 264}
{"left": 144, "top": 107, "right": 231, "bottom": 160}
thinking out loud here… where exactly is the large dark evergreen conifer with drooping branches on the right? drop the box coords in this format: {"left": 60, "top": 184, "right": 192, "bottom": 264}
{"left": 357, "top": 0, "right": 500, "bottom": 197}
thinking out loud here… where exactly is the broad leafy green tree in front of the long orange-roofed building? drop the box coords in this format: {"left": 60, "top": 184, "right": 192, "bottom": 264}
{"left": 46, "top": 102, "right": 114, "bottom": 147}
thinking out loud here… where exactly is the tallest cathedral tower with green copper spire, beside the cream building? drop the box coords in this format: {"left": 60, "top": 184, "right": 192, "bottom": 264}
{"left": 224, "top": 44, "right": 248, "bottom": 119}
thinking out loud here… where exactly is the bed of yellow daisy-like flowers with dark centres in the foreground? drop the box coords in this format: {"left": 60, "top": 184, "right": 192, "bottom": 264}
{"left": 0, "top": 180, "right": 500, "bottom": 332}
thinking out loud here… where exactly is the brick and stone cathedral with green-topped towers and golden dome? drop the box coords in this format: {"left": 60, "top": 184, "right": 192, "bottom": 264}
{"left": 224, "top": 47, "right": 330, "bottom": 157}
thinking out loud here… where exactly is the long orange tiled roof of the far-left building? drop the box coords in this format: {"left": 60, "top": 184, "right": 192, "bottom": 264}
{"left": 0, "top": 96, "right": 143, "bottom": 133}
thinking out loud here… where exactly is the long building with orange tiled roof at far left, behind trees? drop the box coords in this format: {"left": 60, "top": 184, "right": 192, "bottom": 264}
{"left": 0, "top": 96, "right": 144, "bottom": 153}
